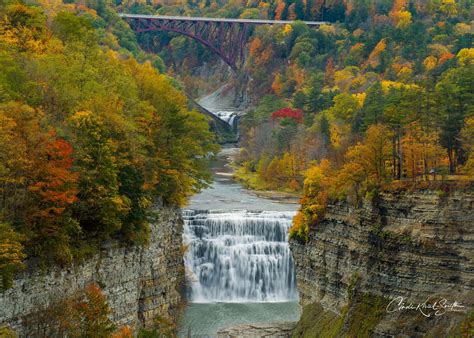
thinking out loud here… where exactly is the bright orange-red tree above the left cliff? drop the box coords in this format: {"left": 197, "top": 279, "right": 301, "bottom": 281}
{"left": 26, "top": 131, "right": 79, "bottom": 263}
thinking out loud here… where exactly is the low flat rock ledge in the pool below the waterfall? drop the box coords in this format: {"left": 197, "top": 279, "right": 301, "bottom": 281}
{"left": 217, "top": 322, "right": 296, "bottom": 338}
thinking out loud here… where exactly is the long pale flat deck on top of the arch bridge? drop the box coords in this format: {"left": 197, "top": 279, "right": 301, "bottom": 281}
{"left": 119, "top": 13, "right": 329, "bottom": 26}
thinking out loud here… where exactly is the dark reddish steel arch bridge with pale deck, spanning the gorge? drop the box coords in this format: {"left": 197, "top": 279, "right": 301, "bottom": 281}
{"left": 119, "top": 14, "right": 328, "bottom": 71}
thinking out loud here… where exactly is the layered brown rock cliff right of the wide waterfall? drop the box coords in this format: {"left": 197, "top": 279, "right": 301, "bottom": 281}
{"left": 290, "top": 185, "right": 474, "bottom": 337}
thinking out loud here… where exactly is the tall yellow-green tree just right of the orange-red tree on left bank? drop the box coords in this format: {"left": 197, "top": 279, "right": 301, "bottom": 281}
{"left": 69, "top": 111, "right": 129, "bottom": 237}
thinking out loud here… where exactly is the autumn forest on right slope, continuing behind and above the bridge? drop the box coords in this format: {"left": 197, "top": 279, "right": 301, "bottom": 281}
{"left": 117, "top": 0, "right": 474, "bottom": 237}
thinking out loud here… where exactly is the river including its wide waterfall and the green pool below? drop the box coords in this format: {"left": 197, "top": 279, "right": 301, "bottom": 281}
{"left": 179, "top": 146, "right": 300, "bottom": 337}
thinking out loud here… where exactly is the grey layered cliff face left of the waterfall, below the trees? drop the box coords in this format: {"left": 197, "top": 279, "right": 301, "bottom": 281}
{"left": 0, "top": 208, "right": 184, "bottom": 336}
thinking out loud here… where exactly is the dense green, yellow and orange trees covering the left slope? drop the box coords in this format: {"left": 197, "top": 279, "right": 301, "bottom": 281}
{"left": 0, "top": 1, "right": 216, "bottom": 287}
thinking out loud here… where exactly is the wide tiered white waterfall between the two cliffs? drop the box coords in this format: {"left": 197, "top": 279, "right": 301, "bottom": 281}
{"left": 183, "top": 210, "right": 297, "bottom": 302}
